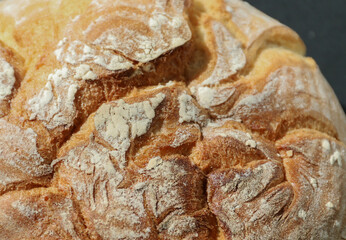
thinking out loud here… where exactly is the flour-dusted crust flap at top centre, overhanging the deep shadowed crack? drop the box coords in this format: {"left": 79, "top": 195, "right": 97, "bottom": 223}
{"left": 89, "top": 0, "right": 191, "bottom": 63}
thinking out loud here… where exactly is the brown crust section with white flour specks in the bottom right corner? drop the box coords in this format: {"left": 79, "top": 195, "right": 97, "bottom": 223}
{"left": 277, "top": 130, "right": 346, "bottom": 239}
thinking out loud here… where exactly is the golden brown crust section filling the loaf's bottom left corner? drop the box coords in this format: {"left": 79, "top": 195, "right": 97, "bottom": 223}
{"left": 0, "top": 188, "right": 88, "bottom": 240}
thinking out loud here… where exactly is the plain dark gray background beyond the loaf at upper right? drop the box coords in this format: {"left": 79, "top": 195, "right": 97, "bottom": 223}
{"left": 247, "top": 0, "right": 346, "bottom": 110}
